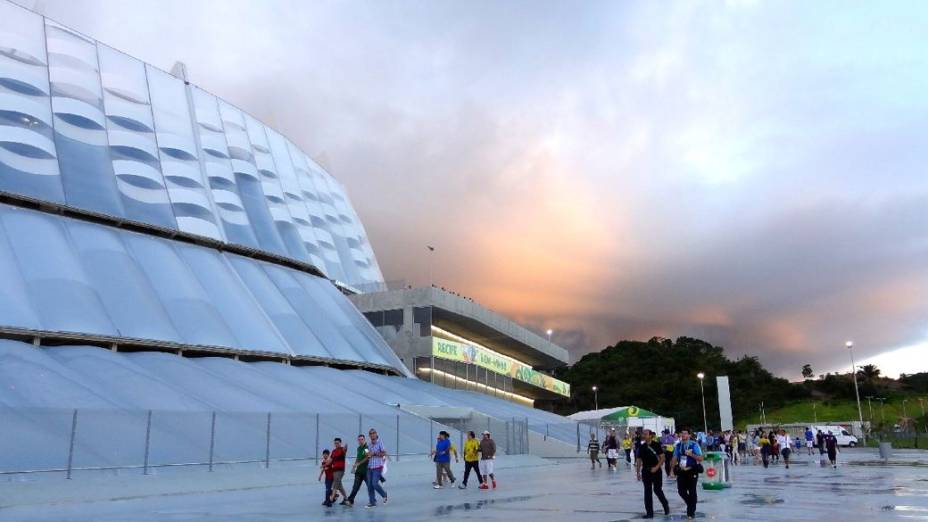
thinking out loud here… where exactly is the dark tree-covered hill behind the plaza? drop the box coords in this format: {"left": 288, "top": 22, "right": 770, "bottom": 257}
{"left": 549, "top": 337, "right": 928, "bottom": 429}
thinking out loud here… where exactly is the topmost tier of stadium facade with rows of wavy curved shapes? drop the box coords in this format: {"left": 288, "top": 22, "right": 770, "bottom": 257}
{"left": 0, "top": 0, "right": 384, "bottom": 283}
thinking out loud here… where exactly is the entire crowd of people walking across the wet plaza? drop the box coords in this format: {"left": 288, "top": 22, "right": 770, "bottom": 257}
{"left": 319, "top": 420, "right": 838, "bottom": 518}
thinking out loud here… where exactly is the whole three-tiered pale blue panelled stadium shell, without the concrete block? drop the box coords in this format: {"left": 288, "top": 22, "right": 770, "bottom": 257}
{"left": 0, "top": 0, "right": 579, "bottom": 476}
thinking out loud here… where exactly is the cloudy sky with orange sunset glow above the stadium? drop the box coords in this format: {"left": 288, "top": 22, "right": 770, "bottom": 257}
{"left": 29, "top": 0, "right": 928, "bottom": 378}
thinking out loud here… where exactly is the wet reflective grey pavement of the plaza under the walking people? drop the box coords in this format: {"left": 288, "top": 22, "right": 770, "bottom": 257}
{"left": 0, "top": 450, "right": 928, "bottom": 522}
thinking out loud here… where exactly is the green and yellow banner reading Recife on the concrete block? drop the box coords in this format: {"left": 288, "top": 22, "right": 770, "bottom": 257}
{"left": 432, "top": 337, "right": 570, "bottom": 397}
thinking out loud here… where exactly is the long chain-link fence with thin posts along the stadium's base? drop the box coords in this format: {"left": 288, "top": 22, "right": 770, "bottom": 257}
{"left": 0, "top": 408, "right": 529, "bottom": 478}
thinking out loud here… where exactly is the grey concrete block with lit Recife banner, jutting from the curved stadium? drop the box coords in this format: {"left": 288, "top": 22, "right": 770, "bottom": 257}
{"left": 349, "top": 286, "right": 570, "bottom": 406}
